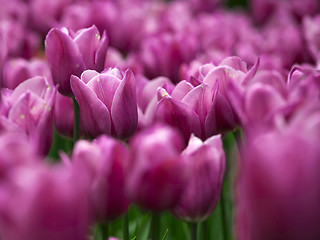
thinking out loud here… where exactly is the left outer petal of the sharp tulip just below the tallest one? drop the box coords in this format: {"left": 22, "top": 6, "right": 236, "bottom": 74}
{"left": 70, "top": 76, "right": 111, "bottom": 137}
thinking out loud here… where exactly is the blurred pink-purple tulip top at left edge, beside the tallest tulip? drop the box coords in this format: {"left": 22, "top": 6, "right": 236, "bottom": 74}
{"left": 3, "top": 58, "right": 51, "bottom": 89}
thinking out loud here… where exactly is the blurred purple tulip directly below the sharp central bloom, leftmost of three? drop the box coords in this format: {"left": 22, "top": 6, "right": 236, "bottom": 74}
{"left": 72, "top": 136, "right": 129, "bottom": 221}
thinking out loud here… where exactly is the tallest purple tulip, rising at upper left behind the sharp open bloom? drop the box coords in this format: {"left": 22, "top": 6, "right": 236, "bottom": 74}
{"left": 45, "top": 26, "right": 108, "bottom": 96}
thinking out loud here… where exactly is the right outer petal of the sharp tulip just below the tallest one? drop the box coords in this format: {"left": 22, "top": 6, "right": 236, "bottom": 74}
{"left": 111, "top": 69, "right": 138, "bottom": 139}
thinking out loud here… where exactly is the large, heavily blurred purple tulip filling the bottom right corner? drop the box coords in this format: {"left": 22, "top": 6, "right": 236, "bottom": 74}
{"left": 235, "top": 120, "right": 320, "bottom": 240}
